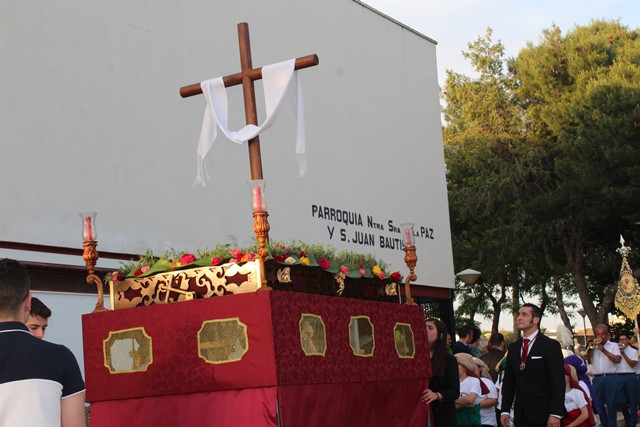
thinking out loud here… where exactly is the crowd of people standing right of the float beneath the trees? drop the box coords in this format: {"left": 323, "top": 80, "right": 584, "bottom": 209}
{"left": 421, "top": 304, "right": 640, "bottom": 427}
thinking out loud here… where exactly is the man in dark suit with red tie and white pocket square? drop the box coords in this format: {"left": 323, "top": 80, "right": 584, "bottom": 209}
{"left": 500, "top": 304, "right": 565, "bottom": 427}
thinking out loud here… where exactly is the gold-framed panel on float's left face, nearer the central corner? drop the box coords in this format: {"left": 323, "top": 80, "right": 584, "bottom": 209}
{"left": 198, "top": 317, "right": 249, "bottom": 363}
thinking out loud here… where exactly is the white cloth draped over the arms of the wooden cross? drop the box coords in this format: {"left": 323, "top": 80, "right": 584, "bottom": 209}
{"left": 193, "top": 59, "right": 307, "bottom": 187}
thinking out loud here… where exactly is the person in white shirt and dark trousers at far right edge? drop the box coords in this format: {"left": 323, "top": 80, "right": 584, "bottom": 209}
{"left": 618, "top": 334, "right": 638, "bottom": 426}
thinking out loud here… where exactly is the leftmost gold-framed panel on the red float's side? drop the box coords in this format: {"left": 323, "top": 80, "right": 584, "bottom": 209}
{"left": 102, "top": 327, "right": 153, "bottom": 374}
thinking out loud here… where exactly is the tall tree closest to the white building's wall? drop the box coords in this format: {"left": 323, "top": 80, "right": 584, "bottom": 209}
{"left": 443, "top": 29, "right": 531, "bottom": 332}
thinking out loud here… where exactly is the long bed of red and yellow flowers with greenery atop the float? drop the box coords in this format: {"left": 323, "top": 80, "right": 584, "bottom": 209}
{"left": 106, "top": 241, "right": 402, "bottom": 281}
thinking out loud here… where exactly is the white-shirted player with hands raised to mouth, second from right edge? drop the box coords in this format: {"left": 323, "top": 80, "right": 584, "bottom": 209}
{"left": 587, "top": 324, "right": 622, "bottom": 427}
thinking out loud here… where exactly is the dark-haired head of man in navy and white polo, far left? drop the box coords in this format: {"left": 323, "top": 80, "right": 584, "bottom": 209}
{"left": 0, "top": 258, "right": 31, "bottom": 323}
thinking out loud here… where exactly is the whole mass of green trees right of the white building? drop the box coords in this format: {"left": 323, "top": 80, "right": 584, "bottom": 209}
{"left": 443, "top": 21, "right": 640, "bottom": 330}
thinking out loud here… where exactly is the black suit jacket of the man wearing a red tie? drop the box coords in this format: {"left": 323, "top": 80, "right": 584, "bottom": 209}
{"left": 500, "top": 332, "right": 565, "bottom": 425}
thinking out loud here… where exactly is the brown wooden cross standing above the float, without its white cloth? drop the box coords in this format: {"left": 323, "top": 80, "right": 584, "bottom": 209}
{"left": 180, "top": 22, "right": 319, "bottom": 180}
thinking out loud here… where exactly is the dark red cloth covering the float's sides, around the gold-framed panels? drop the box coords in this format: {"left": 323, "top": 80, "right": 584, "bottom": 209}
{"left": 83, "top": 291, "right": 431, "bottom": 427}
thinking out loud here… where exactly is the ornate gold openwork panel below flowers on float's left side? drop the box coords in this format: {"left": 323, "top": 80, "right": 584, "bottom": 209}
{"left": 109, "top": 261, "right": 261, "bottom": 310}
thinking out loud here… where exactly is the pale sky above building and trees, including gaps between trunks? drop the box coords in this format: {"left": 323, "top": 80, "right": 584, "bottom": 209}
{"left": 362, "top": 0, "right": 640, "bottom": 330}
